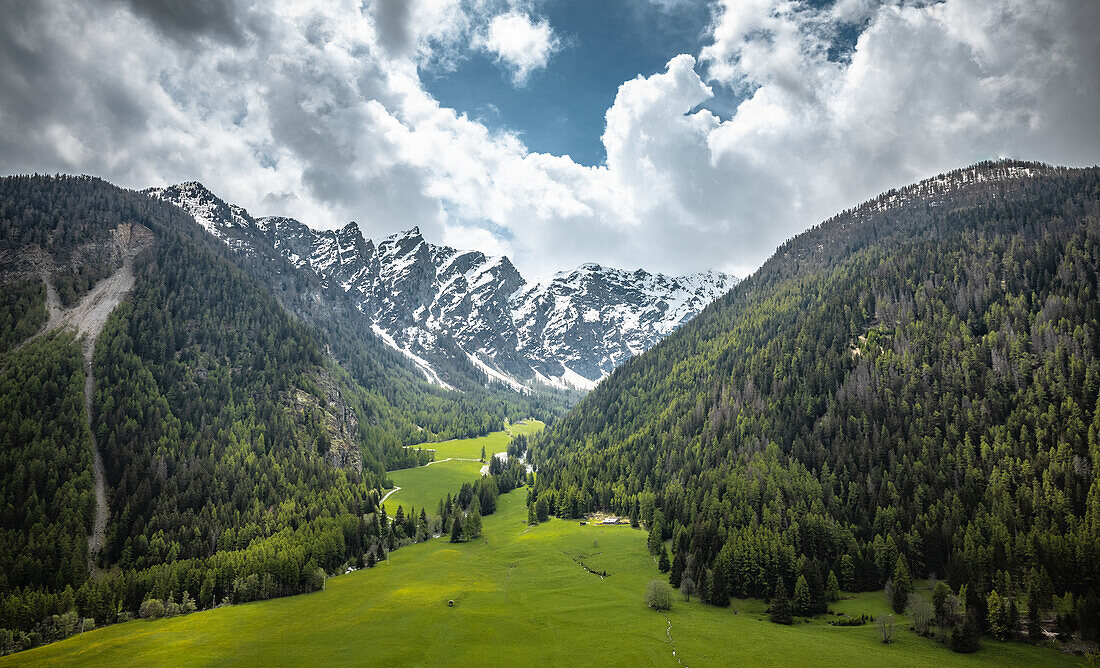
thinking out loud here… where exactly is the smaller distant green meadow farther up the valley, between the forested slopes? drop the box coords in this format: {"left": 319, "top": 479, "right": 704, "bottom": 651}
{"left": 385, "top": 420, "right": 546, "bottom": 515}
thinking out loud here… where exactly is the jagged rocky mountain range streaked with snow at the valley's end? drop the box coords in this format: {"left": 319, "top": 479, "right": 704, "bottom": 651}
{"left": 149, "top": 182, "right": 737, "bottom": 391}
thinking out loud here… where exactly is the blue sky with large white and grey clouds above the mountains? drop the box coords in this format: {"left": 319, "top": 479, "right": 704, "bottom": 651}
{"left": 0, "top": 0, "right": 1100, "bottom": 277}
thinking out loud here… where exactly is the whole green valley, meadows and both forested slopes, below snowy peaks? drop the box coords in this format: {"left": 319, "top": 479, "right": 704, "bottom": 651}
{"left": 0, "top": 167, "right": 1100, "bottom": 666}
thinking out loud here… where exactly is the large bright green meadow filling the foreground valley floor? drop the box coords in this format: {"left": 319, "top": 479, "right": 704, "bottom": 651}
{"left": 12, "top": 490, "right": 1080, "bottom": 667}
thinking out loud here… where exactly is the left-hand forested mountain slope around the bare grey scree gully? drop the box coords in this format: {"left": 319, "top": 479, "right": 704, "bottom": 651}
{"left": 0, "top": 176, "right": 550, "bottom": 651}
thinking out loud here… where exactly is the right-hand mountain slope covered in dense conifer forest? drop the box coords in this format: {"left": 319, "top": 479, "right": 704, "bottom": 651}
{"left": 531, "top": 162, "right": 1100, "bottom": 636}
